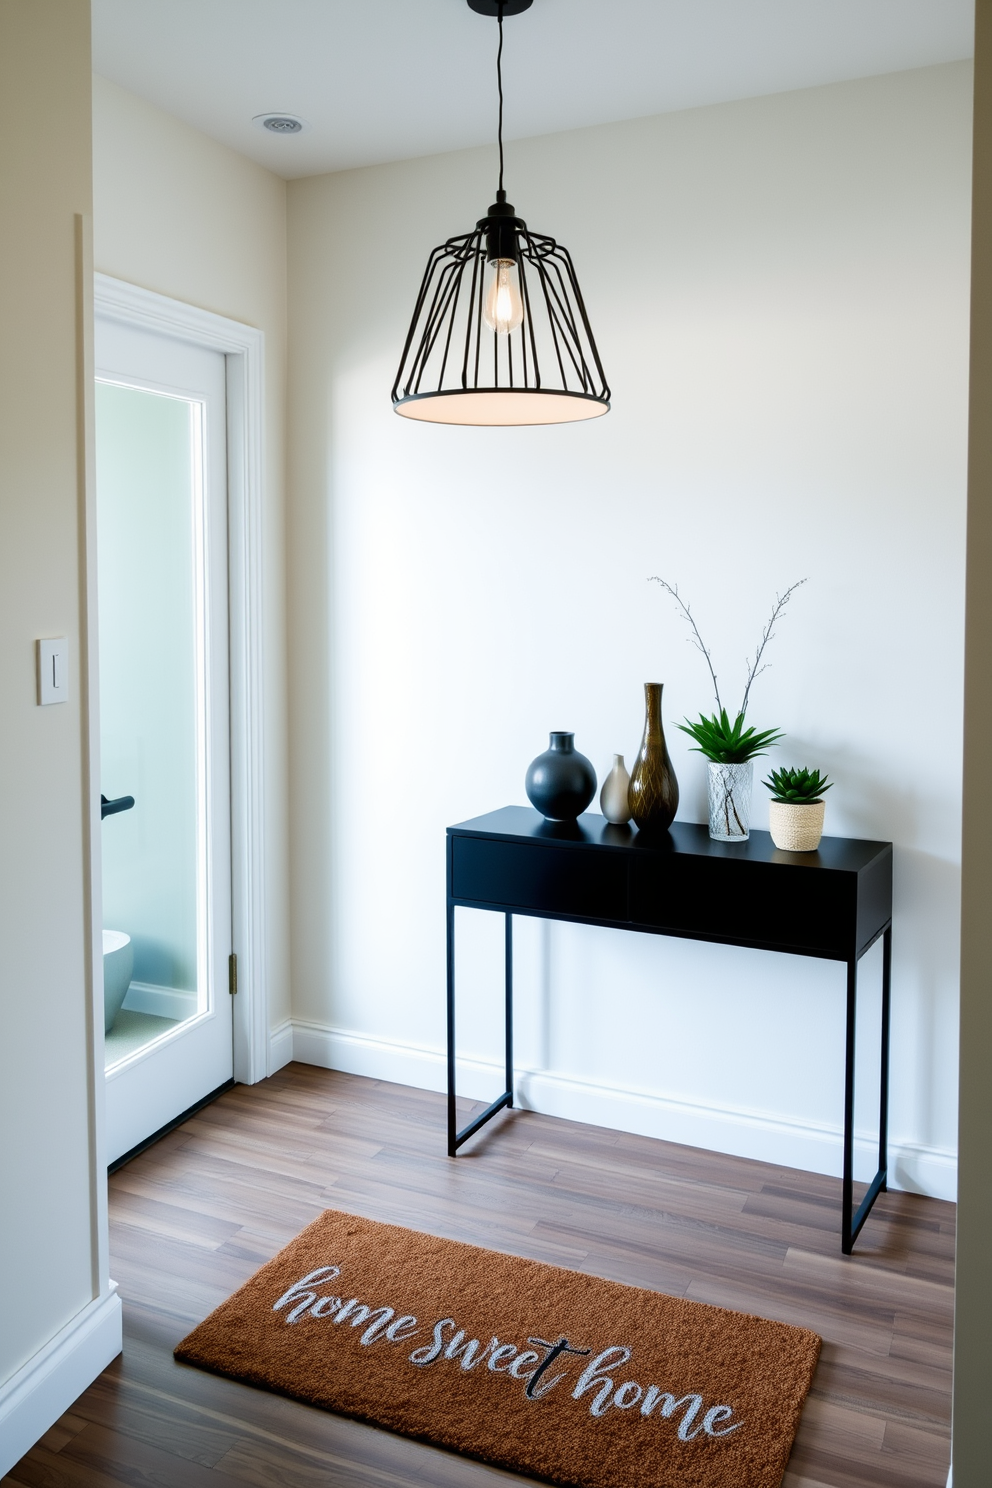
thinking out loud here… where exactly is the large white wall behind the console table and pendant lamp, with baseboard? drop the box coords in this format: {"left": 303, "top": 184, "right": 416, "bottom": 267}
{"left": 280, "top": 64, "right": 971, "bottom": 1195}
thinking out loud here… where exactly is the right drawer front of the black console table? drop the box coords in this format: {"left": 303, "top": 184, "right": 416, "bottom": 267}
{"left": 631, "top": 856, "right": 858, "bottom": 957}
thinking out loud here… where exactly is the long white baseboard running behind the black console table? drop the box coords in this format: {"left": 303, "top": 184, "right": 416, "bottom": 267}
{"left": 271, "top": 1019, "right": 958, "bottom": 1201}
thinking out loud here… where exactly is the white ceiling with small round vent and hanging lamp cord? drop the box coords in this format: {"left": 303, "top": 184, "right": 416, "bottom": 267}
{"left": 92, "top": 0, "right": 974, "bottom": 177}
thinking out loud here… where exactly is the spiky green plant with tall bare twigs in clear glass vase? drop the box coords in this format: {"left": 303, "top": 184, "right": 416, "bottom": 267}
{"left": 654, "top": 577, "right": 806, "bottom": 842}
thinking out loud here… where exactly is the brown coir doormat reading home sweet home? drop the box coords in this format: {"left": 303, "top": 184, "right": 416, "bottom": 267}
{"left": 175, "top": 1210, "right": 819, "bottom": 1488}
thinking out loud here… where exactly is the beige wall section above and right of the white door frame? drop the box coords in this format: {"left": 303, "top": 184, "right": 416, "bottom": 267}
{"left": 94, "top": 77, "right": 290, "bottom": 1025}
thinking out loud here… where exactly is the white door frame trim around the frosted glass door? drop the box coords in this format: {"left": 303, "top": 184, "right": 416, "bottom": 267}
{"left": 89, "top": 274, "right": 269, "bottom": 1085}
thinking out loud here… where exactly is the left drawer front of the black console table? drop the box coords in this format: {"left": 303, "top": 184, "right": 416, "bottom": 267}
{"left": 452, "top": 838, "right": 628, "bottom": 921}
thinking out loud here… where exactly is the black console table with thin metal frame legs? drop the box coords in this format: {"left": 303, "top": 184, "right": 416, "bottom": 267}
{"left": 448, "top": 806, "right": 892, "bottom": 1254}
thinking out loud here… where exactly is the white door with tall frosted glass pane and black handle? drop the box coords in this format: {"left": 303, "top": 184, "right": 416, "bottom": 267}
{"left": 95, "top": 318, "right": 232, "bottom": 1162}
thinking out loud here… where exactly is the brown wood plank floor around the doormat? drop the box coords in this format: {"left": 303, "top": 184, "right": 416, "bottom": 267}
{"left": 3, "top": 1064, "right": 953, "bottom": 1488}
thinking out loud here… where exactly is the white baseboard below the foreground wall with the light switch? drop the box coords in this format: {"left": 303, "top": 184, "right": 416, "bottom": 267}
{"left": 0, "top": 1283, "right": 120, "bottom": 1478}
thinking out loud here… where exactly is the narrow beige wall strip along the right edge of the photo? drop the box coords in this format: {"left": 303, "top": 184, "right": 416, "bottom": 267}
{"left": 953, "top": 0, "right": 992, "bottom": 1488}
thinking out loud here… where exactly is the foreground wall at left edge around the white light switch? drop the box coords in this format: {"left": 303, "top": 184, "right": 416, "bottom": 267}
{"left": 0, "top": 0, "right": 106, "bottom": 1386}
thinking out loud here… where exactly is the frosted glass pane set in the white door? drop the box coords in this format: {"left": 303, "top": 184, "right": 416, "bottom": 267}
{"left": 97, "top": 382, "right": 205, "bottom": 1023}
